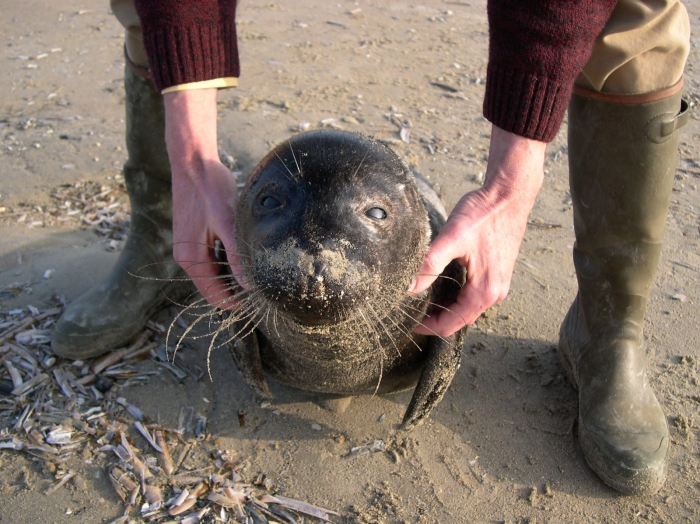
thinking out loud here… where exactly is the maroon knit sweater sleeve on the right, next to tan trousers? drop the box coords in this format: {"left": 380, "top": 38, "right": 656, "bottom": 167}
{"left": 484, "top": 0, "right": 617, "bottom": 142}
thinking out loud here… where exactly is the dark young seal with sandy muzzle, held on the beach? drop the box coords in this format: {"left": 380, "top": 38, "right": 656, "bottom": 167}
{"left": 224, "top": 130, "right": 465, "bottom": 428}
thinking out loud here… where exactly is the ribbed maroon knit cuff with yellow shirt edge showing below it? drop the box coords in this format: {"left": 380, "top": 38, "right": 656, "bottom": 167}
{"left": 144, "top": 20, "right": 240, "bottom": 91}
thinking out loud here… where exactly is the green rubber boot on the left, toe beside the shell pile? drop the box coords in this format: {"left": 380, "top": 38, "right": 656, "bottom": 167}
{"left": 51, "top": 68, "right": 195, "bottom": 359}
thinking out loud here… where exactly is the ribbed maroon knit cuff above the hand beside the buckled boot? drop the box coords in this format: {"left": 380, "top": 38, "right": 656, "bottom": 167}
{"left": 484, "top": 64, "right": 573, "bottom": 142}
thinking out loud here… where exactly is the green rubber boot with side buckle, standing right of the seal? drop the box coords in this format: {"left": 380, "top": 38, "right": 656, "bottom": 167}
{"left": 559, "top": 87, "right": 688, "bottom": 495}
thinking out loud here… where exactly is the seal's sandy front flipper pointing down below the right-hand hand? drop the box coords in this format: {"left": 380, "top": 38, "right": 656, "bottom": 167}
{"left": 401, "top": 331, "right": 464, "bottom": 429}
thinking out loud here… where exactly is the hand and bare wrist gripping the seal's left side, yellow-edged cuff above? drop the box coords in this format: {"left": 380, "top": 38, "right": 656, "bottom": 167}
{"left": 165, "top": 89, "right": 245, "bottom": 309}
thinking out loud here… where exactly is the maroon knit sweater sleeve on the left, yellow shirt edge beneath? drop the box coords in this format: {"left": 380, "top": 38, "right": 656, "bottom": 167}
{"left": 134, "top": 0, "right": 240, "bottom": 90}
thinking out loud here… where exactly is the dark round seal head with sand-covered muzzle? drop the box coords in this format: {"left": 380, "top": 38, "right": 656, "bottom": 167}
{"left": 236, "top": 131, "right": 430, "bottom": 324}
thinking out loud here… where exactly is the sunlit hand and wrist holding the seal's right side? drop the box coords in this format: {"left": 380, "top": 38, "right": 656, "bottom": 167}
{"left": 409, "top": 126, "right": 547, "bottom": 337}
